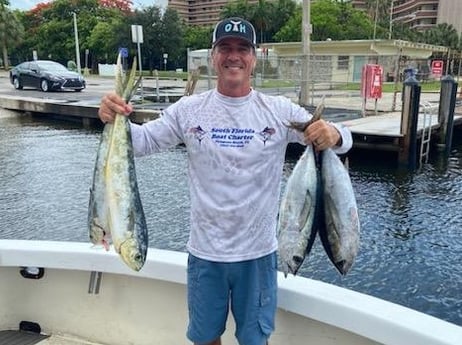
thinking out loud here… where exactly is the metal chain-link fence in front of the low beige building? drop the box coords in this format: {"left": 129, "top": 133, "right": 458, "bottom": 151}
{"left": 188, "top": 50, "right": 458, "bottom": 111}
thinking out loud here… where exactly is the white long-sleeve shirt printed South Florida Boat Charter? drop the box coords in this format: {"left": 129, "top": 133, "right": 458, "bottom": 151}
{"left": 131, "top": 89, "right": 352, "bottom": 262}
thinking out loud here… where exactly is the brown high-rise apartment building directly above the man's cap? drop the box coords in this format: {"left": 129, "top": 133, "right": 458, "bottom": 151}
{"left": 168, "top": 0, "right": 258, "bottom": 26}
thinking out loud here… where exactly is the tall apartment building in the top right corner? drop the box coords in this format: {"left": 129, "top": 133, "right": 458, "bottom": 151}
{"left": 351, "top": 0, "right": 462, "bottom": 34}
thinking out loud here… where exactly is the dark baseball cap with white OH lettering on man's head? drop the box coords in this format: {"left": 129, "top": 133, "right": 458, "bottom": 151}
{"left": 212, "top": 17, "right": 257, "bottom": 48}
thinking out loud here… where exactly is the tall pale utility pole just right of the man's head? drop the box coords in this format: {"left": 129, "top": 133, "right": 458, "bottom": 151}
{"left": 298, "top": 0, "right": 311, "bottom": 106}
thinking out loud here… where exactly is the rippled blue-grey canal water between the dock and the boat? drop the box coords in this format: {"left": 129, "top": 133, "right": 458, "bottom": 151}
{"left": 0, "top": 111, "right": 462, "bottom": 326}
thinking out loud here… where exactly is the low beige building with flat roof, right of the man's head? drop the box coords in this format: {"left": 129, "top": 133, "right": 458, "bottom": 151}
{"left": 260, "top": 40, "right": 448, "bottom": 83}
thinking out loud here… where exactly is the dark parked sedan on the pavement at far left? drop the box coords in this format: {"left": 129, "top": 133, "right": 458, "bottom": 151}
{"left": 10, "top": 60, "right": 86, "bottom": 92}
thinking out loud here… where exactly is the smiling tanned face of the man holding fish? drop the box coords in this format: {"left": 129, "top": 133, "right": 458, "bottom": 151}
{"left": 212, "top": 38, "right": 257, "bottom": 94}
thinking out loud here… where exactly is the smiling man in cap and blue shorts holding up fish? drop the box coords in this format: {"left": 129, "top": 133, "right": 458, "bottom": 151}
{"left": 99, "top": 18, "right": 352, "bottom": 345}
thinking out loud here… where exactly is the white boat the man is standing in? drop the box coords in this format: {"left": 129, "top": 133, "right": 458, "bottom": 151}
{"left": 0, "top": 240, "right": 462, "bottom": 345}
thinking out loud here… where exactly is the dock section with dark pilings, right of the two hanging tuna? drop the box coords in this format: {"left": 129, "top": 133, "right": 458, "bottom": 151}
{"left": 345, "top": 76, "right": 462, "bottom": 169}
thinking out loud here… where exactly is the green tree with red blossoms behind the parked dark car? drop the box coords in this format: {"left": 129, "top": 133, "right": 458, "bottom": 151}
{"left": 11, "top": 0, "right": 132, "bottom": 69}
